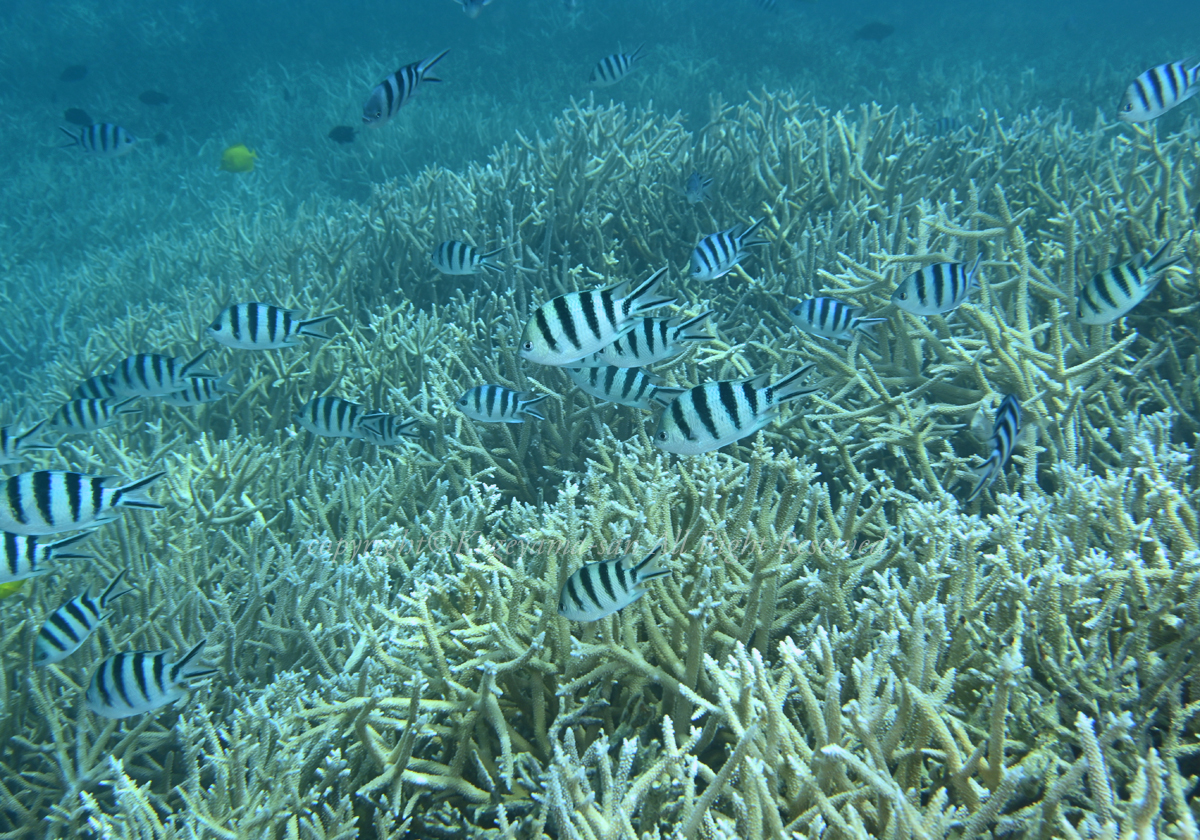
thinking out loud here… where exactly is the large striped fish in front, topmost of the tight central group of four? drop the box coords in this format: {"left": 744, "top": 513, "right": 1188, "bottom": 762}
{"left": 520, "top": 269, "right": 674, "bottom": 367}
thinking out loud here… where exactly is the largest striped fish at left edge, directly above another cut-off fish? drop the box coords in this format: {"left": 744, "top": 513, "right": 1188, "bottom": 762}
{"left": 0, "top": 469, "right": 166, "bottom": 535}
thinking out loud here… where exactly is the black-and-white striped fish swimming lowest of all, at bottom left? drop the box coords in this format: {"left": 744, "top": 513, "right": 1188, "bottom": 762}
{"left": 85, "top": 642, "right": 217, "bottom": 720}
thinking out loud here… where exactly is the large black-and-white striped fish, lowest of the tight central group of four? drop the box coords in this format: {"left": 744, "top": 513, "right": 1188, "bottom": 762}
{"left": 654, "top": 362, "right": 817, "bottom": 455}
